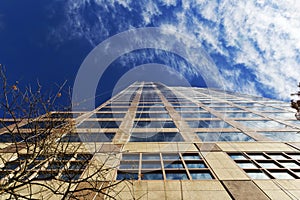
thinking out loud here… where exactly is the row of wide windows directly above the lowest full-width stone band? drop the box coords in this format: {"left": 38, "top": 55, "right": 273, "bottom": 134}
{"left": 0, "top": 131, "right": 300, "bottom": 143}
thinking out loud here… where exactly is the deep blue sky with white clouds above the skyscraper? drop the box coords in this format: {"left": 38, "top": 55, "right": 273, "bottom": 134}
{"left": 0, "top": 0, "right": 300, "bottom": 109}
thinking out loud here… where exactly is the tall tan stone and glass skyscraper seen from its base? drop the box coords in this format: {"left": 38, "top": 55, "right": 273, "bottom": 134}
{"left": 0, "top": 82, "right": 300, "bottom": 199}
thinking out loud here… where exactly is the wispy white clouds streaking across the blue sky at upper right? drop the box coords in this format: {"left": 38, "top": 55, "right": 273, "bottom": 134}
{"left": 56, "top": 0, "right": 300, "bottom": 99}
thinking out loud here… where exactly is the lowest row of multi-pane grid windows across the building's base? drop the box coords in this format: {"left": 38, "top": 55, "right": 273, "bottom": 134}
{"left": 0, "top": 152, "right": 300, "bottom": 181}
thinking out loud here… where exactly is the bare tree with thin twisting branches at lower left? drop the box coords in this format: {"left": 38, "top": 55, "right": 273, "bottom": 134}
{"left": 0, "top": 66, "right": 135, "bottom": 199}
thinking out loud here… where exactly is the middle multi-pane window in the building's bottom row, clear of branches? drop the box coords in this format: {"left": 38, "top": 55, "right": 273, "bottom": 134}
{"left": 117, "top": 153, "right": 214, "bottom": 180}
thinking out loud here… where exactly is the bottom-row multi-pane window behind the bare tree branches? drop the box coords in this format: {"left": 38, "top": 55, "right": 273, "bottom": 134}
{"left": 0, "top": 153, "right": 93, "bottom": 181}
